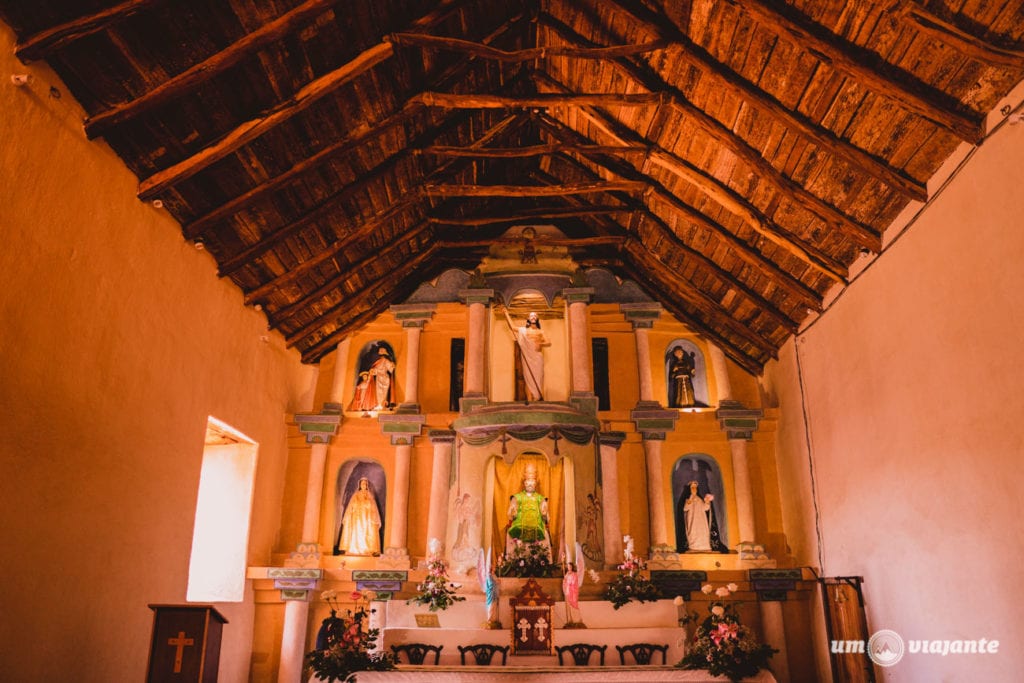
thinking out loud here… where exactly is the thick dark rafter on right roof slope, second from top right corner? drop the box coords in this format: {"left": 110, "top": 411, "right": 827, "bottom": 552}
{"left": 732, "top": 0, "right": 984, "bottom": 144}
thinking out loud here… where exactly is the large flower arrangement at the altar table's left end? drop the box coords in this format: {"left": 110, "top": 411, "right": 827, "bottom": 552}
{"left": 306, "top": 591, "right": 395, "bottom": 681}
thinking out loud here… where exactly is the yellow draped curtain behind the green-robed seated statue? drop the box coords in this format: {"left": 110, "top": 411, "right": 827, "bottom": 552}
{"left": 490, "top": 453, "right": 565, "bottom": 561}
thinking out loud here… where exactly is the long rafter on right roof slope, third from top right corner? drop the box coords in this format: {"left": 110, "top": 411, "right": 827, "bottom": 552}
{"left": 598, "top": 0, "right": 928, "bottom": 202}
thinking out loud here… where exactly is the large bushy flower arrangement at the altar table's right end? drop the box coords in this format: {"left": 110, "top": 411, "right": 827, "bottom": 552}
{"left": 677, "top": 584, "right": 778, "bottom": 681}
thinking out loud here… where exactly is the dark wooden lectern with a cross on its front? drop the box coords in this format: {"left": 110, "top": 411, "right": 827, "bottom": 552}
{"left": 145, "top": 605, "right": 227, "bottom": 683}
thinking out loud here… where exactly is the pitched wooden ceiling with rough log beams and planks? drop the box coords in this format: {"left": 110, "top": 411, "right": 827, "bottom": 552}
{"left": 0, "top": 0, "right": 1024, "bottom": 373}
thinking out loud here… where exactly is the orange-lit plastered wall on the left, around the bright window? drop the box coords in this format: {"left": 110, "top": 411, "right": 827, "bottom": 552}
{"left": 0, "top": 26, "right": 315, "bottom": 683}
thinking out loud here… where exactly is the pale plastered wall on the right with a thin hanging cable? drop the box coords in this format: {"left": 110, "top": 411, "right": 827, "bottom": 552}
{"left": 765, "top": 116, "right": 1024, "bottom": 681}
